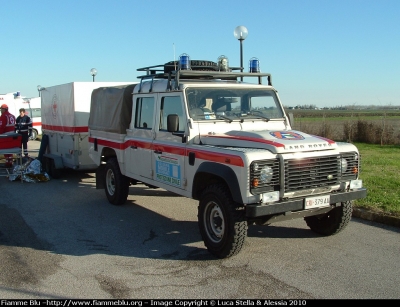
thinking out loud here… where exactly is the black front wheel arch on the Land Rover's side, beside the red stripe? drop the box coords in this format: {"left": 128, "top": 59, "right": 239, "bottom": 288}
{"left": 192, "top": 162, "right": 243, "bottom": 204}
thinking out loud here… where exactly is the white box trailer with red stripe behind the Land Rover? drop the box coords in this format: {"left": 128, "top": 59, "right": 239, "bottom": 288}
{"left": 38, "top": 82, "right": 137, "bottom": 178}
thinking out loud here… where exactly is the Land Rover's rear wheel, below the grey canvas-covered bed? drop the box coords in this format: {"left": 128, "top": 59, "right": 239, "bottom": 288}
{"left": 104, "top": 158, "right": 129, "bottom": 206}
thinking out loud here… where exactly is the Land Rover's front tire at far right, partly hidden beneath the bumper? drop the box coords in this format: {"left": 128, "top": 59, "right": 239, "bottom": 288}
{"left": 304, "top": 201, "right": 353, "bottom": 236}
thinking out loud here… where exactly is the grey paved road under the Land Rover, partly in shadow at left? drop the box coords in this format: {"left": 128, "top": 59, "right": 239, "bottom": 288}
{"left": 0, "top": 142, "right": 400, "bottom": 299}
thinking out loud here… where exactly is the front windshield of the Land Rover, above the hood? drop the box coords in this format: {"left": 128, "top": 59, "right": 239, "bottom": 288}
{"left": 186, "top": 88, "right": 283, "bottom": 121}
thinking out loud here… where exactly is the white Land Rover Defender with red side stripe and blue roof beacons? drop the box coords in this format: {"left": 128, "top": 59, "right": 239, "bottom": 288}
{"left": 89, "top": 55, "right": 367, "bottom": 258}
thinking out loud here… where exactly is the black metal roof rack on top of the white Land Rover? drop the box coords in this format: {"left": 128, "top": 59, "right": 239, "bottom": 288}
{"left": 137, "top": 61, "right": 272, "bottom": 93}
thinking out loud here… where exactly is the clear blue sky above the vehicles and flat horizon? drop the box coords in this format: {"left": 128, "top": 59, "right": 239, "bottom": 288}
{"left": 0, "top": 0, "right": 400, "bottom": 107}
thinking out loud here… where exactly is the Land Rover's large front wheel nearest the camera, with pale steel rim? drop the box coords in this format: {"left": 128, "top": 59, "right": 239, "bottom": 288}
{"left": 198, "top": 184, "right": 247, "bottom": 258}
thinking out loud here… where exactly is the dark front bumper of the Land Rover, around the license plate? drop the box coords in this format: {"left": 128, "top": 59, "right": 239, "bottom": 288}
{"left": 246, "top": 188, "right": 367, "bottom": 218}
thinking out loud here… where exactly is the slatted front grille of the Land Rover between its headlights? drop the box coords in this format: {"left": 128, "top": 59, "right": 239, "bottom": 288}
{"left": 285, "top": 155, "right": 341, "bottom": 193}
